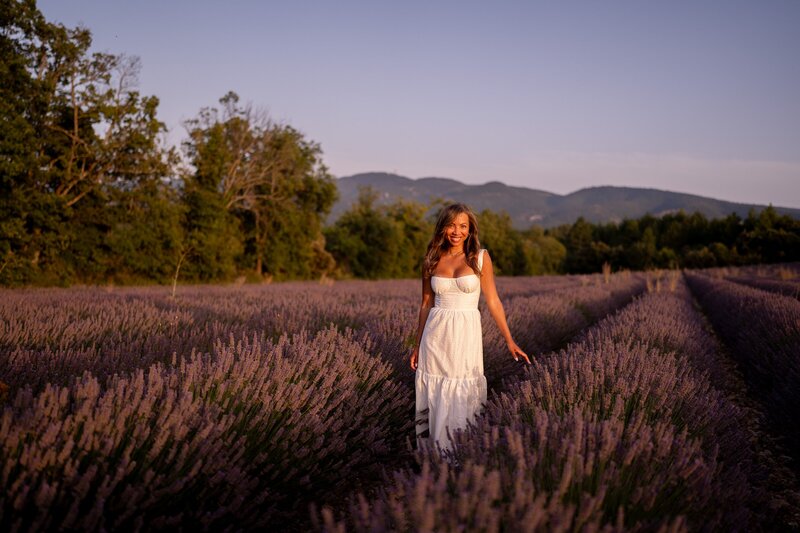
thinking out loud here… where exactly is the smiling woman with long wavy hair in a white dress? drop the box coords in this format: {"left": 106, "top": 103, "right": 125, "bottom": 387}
{"left": 411, "top": 204, "right": 530, "bottom": 449}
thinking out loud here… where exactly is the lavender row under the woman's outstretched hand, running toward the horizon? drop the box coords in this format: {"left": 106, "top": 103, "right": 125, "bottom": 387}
{"left": 322, "top": 280, "right": 769, "bottom": 531}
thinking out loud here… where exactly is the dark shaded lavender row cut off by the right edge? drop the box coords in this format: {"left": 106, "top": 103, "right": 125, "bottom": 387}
{"left": 686, "top": 273, "right": 800, "bottom": 471}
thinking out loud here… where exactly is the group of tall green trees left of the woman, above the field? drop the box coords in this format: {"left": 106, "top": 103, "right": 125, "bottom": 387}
{"left": 0, "top": 1, "right": 337, "bottom": 285}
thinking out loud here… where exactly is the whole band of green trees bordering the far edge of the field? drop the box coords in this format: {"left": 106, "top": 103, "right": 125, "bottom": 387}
{"left": 0, "top": 0, "right": 800, "bottom": 285}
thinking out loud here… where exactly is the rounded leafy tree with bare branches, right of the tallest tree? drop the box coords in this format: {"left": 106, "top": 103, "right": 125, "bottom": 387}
{"left": 184, "top": 92, "right": 338, "bottom": 278}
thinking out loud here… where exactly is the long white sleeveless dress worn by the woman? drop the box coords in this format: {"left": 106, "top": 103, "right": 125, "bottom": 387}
{"left": 415, "top": 250, "right": 486, "bottom": 449}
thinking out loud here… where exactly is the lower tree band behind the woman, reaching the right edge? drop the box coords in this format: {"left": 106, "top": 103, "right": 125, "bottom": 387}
{"left": 324, "top": 188, "right": 800, "bottom": 278}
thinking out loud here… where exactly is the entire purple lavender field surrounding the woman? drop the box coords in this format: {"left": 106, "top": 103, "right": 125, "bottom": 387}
{"left": 0, "top": 264, "right": 800, "bottom": 532}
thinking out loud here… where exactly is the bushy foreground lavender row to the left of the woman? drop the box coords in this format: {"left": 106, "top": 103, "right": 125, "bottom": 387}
{"left": 0, "top": 330, "right": 413, "bottom": 531}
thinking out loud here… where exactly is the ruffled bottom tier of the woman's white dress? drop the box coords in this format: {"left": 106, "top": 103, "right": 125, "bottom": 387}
{"left": 415, "top": 371, "right": 486, "bottom": 448}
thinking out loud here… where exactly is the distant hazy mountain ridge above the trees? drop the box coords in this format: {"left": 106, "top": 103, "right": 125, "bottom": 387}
{"left": 329, "top": 172, "right": 800, "bottom": 229}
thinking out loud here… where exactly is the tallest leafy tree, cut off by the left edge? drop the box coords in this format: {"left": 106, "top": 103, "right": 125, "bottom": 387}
{"left": 0, "top": 0, "right": 175, "bottom": 283}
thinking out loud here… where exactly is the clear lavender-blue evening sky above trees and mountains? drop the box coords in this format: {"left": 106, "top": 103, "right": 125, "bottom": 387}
{"left": 38, "top": 0, "right": 800, "bottom": 207}
